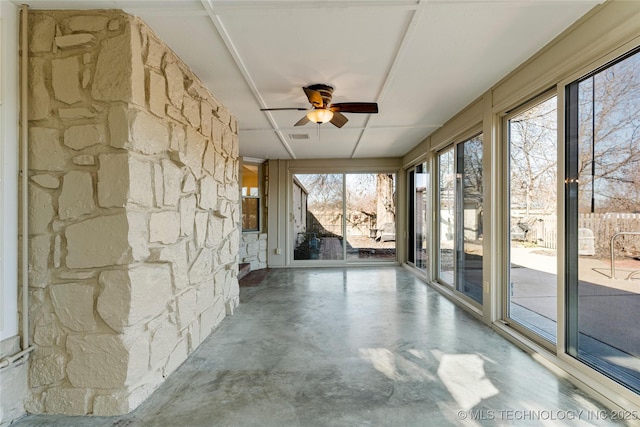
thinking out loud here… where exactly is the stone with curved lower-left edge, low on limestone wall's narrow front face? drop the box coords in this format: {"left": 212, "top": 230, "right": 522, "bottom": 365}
{"left": 50, "top": 283, "right": 98, "bottom": 332}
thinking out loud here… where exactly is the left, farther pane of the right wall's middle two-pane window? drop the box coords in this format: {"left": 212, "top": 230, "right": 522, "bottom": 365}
{"left": 438, "top": 149, "right": 456, "bottom": 285}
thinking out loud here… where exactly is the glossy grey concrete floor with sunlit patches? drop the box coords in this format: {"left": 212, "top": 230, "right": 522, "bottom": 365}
{"left": 13, "top": 267, "right": 622, "bottom": 427}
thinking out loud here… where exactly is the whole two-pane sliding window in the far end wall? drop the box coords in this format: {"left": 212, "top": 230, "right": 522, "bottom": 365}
{"left": 292, "top": 173, "right": 396, "bottom": 262}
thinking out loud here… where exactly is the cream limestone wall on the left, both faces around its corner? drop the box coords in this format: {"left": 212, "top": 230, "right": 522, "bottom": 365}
{"left": 26, "top": 10, "right": 240, "bottom": 415}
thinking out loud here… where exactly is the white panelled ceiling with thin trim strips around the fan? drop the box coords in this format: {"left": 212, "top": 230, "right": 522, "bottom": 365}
{"left": 18, "top": 0, "right": 601, "bottom": 159}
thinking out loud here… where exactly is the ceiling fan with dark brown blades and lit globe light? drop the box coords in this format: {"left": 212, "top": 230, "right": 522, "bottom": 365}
{"left": 260, "top": 84, "right": 378, "bottom": 128}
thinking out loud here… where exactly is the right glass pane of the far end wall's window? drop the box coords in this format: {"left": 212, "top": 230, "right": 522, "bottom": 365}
{"left": 345, "top": 173, "right": 396, "bottom": 261}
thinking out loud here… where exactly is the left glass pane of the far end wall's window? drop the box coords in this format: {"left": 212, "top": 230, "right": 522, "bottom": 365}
{"left": 293, "top": 174, "right": 344, "bottom": 260}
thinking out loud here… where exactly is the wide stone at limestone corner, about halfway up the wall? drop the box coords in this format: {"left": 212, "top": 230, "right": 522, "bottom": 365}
{"left": 65, "top": 213, "right": 142, "bottom": 268}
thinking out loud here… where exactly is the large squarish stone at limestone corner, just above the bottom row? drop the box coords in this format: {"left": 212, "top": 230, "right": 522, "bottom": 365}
{"left": 67, "top": 334, "right": 130, "bottom": 389}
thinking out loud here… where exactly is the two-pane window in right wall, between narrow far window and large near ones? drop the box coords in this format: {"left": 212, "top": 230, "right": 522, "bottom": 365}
{"left": 438, "top": 135, "right": 484, "bottom": 304}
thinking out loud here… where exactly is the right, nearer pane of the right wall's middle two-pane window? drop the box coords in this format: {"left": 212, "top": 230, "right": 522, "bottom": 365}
{"left": 456, "top": 135, "right": 483, "bottom": 304}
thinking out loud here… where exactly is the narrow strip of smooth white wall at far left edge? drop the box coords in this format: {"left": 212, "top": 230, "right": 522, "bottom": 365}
{"left": 0, "top": 1, "right": 19, "bottom": 340}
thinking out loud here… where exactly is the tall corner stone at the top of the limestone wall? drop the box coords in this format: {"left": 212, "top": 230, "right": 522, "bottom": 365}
{"left": 91, "top": 30, "right": 145, "bottom": 106}
